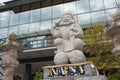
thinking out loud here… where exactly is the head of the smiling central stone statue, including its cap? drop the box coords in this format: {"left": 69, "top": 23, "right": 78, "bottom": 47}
{"left": 59, "top": 13, "right": 75, "bottom": 26}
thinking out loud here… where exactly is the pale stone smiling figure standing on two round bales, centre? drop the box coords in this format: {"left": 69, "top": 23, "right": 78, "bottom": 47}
{"left": 51, "top": 13, "right": 86, "bottom": 65}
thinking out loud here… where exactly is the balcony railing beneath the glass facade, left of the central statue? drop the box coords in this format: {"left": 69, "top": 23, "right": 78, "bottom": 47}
{"left": 18, "top": 37, "right": 54, "bottom": 50}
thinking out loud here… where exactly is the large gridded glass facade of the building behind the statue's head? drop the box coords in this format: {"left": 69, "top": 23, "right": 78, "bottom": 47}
{"left": 0, "top": 0, "right": 117, "bottom": 39}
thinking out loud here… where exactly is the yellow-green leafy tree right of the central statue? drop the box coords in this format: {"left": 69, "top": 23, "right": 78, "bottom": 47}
{"left": 82, "top": 24, "right": 120, "bottom": 69}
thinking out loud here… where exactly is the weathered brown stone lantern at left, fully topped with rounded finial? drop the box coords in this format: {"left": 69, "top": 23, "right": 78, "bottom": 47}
{"left": 0, "top": 33, "right": 23, "bottom": 80}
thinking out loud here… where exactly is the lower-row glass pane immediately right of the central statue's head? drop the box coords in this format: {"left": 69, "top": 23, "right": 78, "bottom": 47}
{"left": 78, "top": 14, "right": 91, "bottom": 28}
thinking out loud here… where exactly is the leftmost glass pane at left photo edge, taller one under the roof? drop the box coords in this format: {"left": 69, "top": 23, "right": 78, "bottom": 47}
{"left": 0, "top": 11, "right": 10, "bottom": 27}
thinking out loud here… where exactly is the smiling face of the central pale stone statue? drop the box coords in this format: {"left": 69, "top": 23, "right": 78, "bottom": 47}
{"left": 60, "top": 15, "right": 75, "bottom": 26}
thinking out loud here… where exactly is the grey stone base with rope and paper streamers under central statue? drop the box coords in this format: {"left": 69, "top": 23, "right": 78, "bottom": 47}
{"left": 43, "top": 62, "right": 107, "bottom": 80}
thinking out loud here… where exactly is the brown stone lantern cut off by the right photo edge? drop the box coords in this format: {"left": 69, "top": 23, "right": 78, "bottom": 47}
{"left": 105, "top": 7, "right": 120, "bottom": 56}
